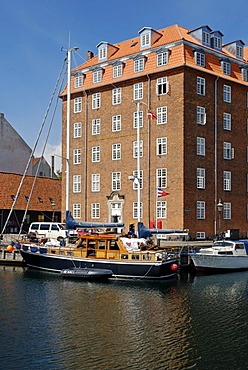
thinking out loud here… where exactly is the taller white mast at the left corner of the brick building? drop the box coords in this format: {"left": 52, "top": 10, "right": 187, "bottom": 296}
{"left": 65, "top": 47, "right": 78, "bottom": 211}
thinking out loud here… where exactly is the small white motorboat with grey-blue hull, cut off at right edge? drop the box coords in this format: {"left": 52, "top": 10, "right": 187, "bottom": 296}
{"left": 190, "top": 240, "right": 248, "bottom": 273}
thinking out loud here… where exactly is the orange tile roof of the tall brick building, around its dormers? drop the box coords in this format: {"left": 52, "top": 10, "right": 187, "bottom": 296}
{"left": 61, "top": 25, "right": 248, "bottom": 95}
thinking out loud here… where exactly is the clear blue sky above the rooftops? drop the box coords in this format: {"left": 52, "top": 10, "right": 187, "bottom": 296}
{"left": 0, "top": 0, "right": 248, "bottom": 169}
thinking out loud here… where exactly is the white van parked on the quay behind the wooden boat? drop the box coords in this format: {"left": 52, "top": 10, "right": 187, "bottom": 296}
{"left": 28, "top": 222, "right": 67, "bottom": 239}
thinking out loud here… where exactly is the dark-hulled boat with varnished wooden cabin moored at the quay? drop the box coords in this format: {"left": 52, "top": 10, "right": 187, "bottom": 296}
{"left": 20, "top": 234, "right": 178, "bottom": 280}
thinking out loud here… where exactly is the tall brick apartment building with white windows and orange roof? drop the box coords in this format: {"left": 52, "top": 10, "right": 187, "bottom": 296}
{"left": 61, "top": 25, "right": 248, "bottom": 238}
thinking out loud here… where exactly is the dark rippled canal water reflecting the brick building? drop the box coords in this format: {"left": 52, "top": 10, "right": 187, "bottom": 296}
{"left": 0, "top": 266, "right": 248, "bottom": 370}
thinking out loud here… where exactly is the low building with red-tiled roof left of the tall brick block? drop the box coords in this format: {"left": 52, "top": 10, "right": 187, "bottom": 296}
{"left": 0, "top": 172, "right": 61, "bottom": 233}
